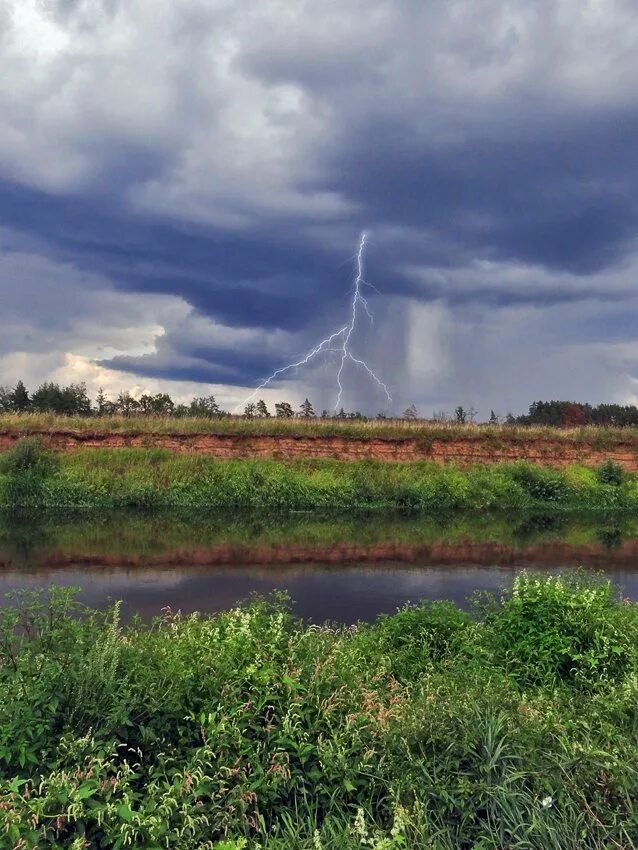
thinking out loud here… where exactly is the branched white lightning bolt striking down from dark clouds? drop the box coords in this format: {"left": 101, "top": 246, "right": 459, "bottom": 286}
{"left": 236, "top": 231, "right": 392, "bottom": 410}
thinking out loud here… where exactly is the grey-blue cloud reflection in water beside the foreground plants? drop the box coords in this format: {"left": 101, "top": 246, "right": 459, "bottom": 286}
{"left": 0, "top": 564, "right": 638, "bottom": 622}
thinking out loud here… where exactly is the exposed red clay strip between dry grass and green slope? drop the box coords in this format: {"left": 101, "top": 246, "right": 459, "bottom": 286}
{"left": 0, "top": 431, "right": 638, "bottom": 472}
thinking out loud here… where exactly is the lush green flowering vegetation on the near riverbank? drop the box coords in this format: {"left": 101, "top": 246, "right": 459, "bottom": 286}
{"left": 0, "top": 575, "right": 638, "bottom": 850}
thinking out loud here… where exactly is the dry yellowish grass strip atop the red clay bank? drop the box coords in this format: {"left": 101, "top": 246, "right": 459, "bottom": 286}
{"left": 0, "top": 413, "right": 638, "bottom": 450}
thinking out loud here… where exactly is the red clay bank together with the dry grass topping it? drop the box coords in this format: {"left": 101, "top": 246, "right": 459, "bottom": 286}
{"left": 0, "top": 414, "right": 638, "bottom": 464}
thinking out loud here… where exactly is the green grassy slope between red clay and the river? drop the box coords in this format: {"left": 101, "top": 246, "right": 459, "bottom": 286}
{"left": 0, "top": 438, "right": 638, "bottom": 513}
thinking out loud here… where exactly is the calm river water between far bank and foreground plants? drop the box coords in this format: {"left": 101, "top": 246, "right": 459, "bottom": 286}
{"left": 0, "top": 514, "right": 638, "bottom": 623}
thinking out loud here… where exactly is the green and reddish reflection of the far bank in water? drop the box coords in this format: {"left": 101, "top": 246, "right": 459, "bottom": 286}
{"left": 0, "top": 512, "right": 638, "bottom": 570}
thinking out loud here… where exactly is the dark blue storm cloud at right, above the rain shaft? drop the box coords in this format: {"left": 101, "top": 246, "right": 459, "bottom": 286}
{"left": 332, "top": 103, "right": 638, "bottom": 274}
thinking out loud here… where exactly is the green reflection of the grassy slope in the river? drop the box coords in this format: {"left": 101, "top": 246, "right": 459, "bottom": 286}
{"left": 0, "top": 510, "right": 638, "bottom": 570}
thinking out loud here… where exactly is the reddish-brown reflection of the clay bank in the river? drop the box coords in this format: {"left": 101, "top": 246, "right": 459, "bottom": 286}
{"left": 5, "top": 540, "right": 638, "bottom": 569}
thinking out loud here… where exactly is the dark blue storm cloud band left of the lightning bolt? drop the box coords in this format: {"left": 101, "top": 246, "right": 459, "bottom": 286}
{"left": 0, "top": 181, "right": 348, "bottom": 330}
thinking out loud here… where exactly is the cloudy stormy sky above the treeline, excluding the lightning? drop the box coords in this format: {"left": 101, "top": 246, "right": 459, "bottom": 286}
{"left": 0, "top": 0, "right": 638, "bottom": 418}
